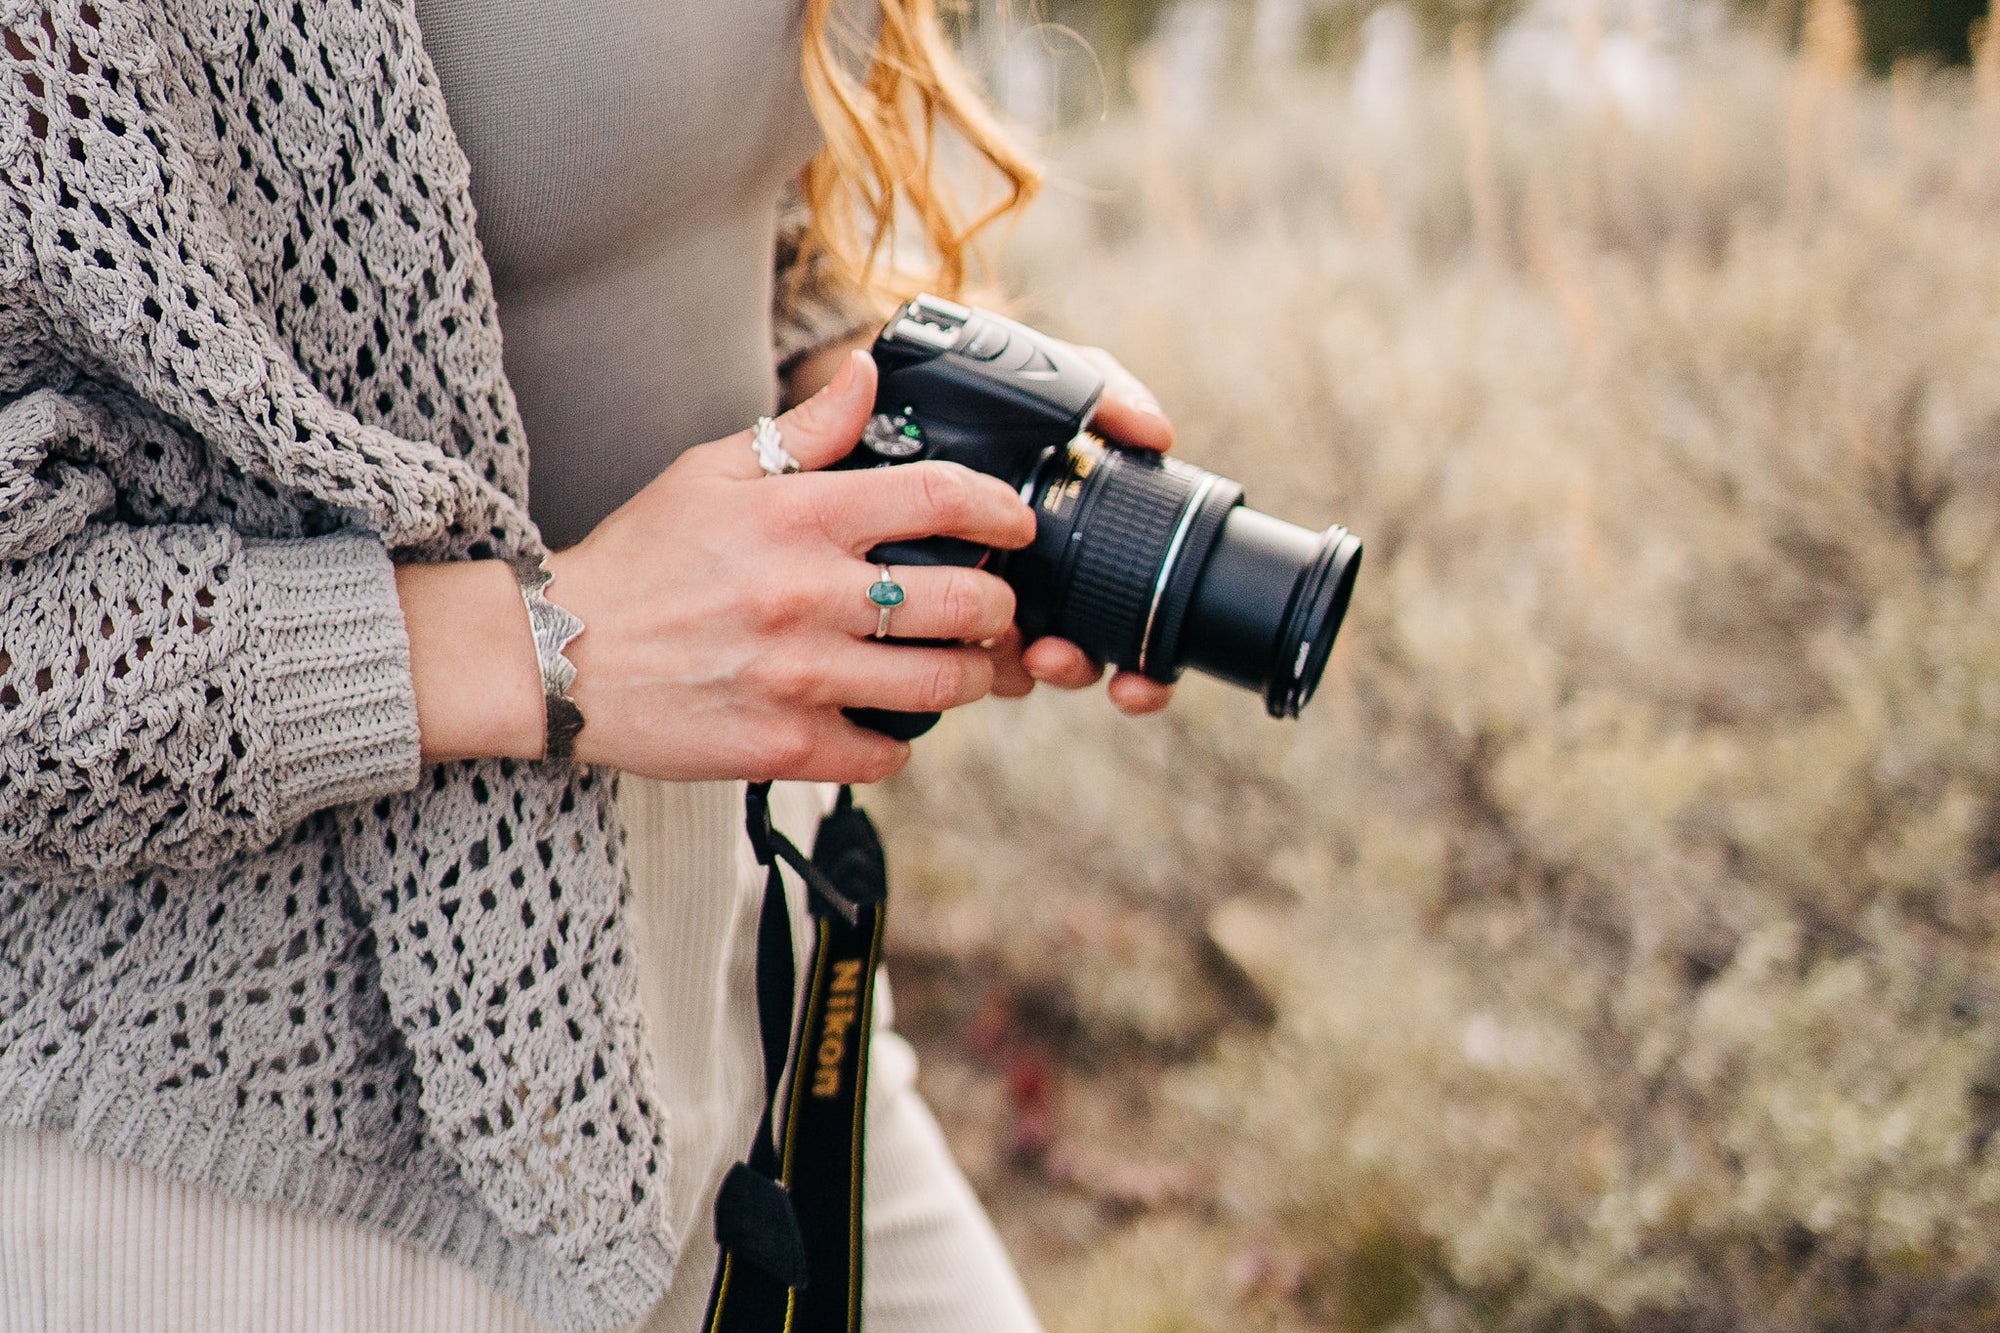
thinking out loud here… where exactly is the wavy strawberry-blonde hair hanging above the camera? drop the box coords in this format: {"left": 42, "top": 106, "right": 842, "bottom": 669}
{"left": 800, "top": 0, "right": 1042, "bottom": 304}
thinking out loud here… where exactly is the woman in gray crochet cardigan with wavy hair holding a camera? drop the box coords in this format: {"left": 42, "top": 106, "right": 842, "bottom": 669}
{"left": 0, "top": 0, "right": 1170, "bottom": 1329}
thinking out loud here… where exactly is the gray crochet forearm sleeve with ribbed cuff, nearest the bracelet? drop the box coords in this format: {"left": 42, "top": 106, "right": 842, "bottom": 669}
{"left": 0, "top": 382, "right": 418, "bottom": 881}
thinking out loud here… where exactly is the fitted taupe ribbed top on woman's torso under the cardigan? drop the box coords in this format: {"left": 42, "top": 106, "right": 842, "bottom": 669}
{"left": 416, "top": 0, "right": 836, "bottom": 546}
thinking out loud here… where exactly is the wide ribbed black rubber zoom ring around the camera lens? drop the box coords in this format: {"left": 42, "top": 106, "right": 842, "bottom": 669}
{"left": 1058, "top": 454, "right": 1200, "bottom": 667}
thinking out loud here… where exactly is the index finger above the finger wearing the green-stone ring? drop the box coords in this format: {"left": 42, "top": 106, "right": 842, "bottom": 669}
{"left": 794, "top": 462, "right": 1034, "bottom": 554}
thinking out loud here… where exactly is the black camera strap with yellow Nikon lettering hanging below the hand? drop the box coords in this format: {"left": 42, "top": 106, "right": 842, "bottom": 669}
{"left": 702, "top": 783, "right": 888, "bottom": 1333}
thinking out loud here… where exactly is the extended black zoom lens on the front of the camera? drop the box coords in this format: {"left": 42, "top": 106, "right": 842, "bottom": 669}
{"left": 1006, "top": 438, "right": 1362, "bottom": 717}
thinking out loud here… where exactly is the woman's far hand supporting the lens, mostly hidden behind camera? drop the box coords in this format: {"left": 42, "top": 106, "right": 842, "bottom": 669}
{"left": 784, "top": 334, "right": 1174, "bottom": 717}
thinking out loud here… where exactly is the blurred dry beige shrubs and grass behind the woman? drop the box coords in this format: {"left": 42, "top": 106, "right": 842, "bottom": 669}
{"left": 872, "top": 0, "right": 2000, "bottom": 1333}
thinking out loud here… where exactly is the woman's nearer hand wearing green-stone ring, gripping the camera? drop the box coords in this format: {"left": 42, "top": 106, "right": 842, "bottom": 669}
{"left": 400, "top": 352, "right": 1034, "bottom": 783}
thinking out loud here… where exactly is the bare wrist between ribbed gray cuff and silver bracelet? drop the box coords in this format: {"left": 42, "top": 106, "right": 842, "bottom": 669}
{"left": 396, "top": 560, "right": 546, "bottom": 763}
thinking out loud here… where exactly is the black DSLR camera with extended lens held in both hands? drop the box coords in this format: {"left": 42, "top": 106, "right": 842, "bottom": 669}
{"left": 836, "top": 296, "right": 1362, "bottom": 741}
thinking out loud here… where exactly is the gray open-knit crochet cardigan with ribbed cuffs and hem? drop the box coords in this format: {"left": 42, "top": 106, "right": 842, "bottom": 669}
{"left": 0, "top": 0, "right": 864, "bottom": 1329}
